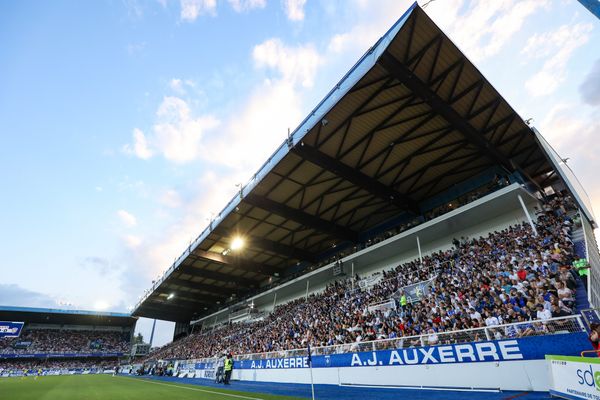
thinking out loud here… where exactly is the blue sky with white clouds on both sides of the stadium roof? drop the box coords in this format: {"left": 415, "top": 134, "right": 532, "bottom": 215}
{"left": 0, "top": 0, "right": 600, "bottom": 343}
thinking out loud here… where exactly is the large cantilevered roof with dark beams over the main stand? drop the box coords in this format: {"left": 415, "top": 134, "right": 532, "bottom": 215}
{"left": 133, "top": 3, "right": 556, "bottom": 321}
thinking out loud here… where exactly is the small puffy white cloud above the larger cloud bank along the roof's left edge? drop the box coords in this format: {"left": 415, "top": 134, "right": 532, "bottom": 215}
{"left": 252, "top": 39, "right": 321, "bottom": 87}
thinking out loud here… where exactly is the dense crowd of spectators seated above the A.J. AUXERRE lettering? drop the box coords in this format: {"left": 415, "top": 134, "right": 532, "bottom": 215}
{"left": 150, "top": 196, "right": 578, "bottom": 359}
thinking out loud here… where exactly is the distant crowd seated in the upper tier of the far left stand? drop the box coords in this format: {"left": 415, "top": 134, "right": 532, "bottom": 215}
{"left": 0, "top": 329, "right": 130, "bottom": 354}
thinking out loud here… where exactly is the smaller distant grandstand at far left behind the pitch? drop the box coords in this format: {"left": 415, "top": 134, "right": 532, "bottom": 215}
{"left": 0, "top": 306, "right": 137, "bottom": 376}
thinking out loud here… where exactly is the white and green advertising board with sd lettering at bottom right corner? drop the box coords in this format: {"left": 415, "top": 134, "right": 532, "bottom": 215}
{"left": 546, "top": 355, "right": 600, "bottom": 400}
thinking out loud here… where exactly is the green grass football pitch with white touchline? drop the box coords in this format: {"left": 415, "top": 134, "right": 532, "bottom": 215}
{"left": 0, "top": 375, "right": 298, "bottom": 400}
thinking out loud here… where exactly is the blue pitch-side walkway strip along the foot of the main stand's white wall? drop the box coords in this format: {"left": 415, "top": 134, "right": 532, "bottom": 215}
{"left": 126, "top": 376, "right": 551, "bottom": 400}
